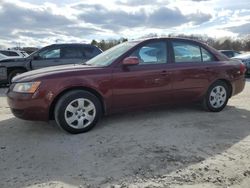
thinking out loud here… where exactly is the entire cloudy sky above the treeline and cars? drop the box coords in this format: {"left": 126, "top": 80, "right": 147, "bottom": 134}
{"left": 0, "top": 0, "right": 250, "bottom": 47}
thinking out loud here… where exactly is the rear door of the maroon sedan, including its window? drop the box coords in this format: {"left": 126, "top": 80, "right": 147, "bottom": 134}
{"left": 171, "top": 39, "right": 216, "bottom": 102}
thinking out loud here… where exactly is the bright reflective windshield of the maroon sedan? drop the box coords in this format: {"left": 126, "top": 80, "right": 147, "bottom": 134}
{"left": 86, "top": 42, "right": 137, "bottom": 67}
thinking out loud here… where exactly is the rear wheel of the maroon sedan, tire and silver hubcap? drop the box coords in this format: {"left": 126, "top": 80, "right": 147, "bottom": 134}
{"left": 203, "top": 81, "right": 229, "bottom": 112}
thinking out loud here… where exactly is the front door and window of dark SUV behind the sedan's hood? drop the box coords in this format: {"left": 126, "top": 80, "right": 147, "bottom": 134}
{"left": 31, "top": 46, "right": 62, "bottom": 69}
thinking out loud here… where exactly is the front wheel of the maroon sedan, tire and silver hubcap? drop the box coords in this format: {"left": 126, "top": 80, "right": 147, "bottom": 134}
{"left": 54, "top": 90, "right": 102, "bottom": 134}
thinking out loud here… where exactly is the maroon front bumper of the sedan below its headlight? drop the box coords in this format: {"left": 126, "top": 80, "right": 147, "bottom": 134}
{"left": 7, "top": 90, "right": 49, "bottom": 121}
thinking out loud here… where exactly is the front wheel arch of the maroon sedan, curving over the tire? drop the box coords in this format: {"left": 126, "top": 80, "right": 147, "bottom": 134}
{"left": 49, "top": 86, "right": 106, "bottom": 120}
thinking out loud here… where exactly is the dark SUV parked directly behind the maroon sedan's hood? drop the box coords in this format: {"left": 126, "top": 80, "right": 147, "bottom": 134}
{"left": 0, "top": 44, "right": 102, "bottom": 83}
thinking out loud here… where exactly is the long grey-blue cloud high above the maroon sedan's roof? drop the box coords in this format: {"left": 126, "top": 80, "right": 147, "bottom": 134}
{"left": 78, "top": 4, "right": 211, "bottom": 31}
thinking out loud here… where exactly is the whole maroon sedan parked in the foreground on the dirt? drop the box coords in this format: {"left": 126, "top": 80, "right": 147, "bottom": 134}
{"left": 7, "top": 38, "right": 245, "bottom": 133}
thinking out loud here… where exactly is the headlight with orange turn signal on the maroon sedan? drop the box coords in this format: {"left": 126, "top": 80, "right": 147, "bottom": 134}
{"left": 13, "top": 82, "right": 41, "bottom": 93}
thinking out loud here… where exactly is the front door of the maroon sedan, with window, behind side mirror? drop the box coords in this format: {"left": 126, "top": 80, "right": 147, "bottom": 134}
{"left": 113, "top": 40, "right": 171, "bottom": 110}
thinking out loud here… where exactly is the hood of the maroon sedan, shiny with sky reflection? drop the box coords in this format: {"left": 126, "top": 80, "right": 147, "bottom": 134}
{"left": 12, "top": 64, "right": 99, "bottom": 82}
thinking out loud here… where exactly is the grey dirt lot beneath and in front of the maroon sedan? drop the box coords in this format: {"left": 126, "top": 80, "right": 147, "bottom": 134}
{"left": 0, "top": 79, "right": 250, "bottom": 188}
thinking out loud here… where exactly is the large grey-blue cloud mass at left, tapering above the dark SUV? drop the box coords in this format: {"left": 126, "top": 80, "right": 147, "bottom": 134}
{"left": 0, "top": 2, "right": 101, "bottom": 46}
